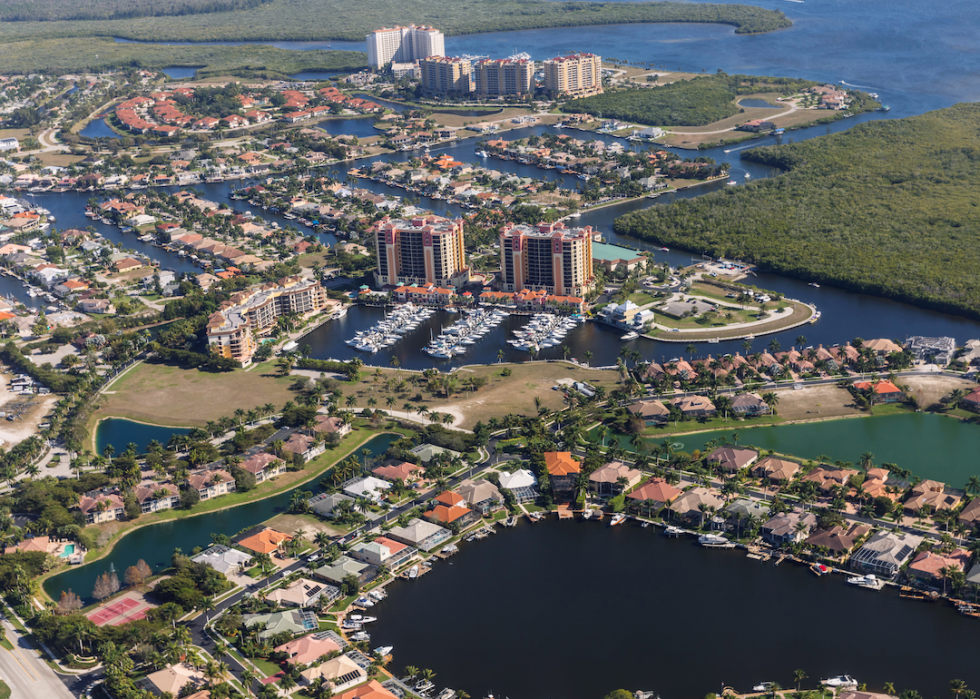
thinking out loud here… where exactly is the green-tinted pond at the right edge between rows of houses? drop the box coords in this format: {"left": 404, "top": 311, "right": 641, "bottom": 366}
{"left": 644, "top": 416, "right": 980, "bottom": 488}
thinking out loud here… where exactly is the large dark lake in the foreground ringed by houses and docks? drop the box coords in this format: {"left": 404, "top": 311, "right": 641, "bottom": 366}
{"left": 371, "top": 518, "right": 980, "bottom": 699}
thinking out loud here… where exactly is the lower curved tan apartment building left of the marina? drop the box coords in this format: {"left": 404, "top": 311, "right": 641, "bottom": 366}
{"left": 207, "top": 277, "right": 327, "bottom": 366}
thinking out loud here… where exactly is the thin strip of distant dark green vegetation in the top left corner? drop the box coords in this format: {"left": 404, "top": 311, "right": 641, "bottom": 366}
{"left": 0, "top": 0, "right": 262, "bottom": 22}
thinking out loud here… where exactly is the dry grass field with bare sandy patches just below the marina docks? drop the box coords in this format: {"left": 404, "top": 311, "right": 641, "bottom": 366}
{"left": 344, "top": 362, "right": 619, "bottom": 429}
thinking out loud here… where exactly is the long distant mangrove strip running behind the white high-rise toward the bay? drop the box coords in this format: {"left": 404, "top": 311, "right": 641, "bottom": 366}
{"left": 0, "top": 0, "right": 792, "bottom": 45}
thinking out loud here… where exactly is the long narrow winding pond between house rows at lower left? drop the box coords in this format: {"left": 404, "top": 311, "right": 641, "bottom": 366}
{"left": 44, "top": 433, "right": 401, "bottom": 604}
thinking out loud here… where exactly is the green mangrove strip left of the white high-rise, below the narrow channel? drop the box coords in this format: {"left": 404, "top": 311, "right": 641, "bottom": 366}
{"left": 0, "top": 38, "right": 367, "bottom": 77}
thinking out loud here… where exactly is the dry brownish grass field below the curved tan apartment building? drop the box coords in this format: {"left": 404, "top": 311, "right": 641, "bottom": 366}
{"left": 91, "top": 362, "right": 296, "bottom": 427}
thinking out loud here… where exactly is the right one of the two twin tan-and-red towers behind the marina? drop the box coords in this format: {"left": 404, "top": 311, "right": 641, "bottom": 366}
{"left": 500, "top": 221, "right": 595, "bottom": 297}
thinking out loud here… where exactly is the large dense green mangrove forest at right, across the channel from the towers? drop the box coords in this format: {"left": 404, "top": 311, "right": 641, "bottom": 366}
{"left": 614, "top": 104, "right": 980, "bottom": 318}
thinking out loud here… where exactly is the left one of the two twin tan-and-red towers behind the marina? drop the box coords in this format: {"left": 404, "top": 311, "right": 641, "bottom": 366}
{"left": 374, "top": 215, "right": 470, "bottom": 287}
